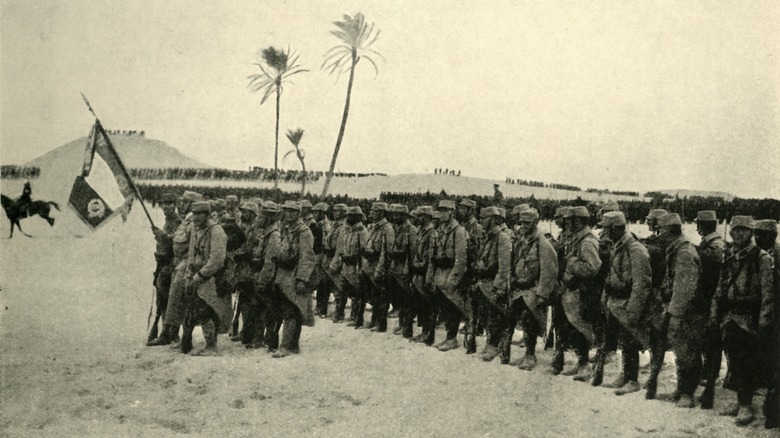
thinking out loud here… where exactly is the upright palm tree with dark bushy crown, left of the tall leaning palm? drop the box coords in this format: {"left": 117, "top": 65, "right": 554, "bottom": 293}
{"left": 247, "top": 46, "right": 308, "bottom": 189}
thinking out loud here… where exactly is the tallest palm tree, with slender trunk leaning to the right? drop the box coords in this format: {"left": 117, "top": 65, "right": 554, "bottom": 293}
{"left": 322, "top": 12, "right": 382, "bottom": 196}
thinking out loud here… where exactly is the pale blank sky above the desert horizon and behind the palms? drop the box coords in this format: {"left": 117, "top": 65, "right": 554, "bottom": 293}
{"left": 0, "top": 0, "right": 780, "bottom": 198}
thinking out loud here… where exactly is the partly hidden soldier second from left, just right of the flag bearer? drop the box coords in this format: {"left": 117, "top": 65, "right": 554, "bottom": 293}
{"left": 161, "top": 191, "right": 203, "bottom": 348}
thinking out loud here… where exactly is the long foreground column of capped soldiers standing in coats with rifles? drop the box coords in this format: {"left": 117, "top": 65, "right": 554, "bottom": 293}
{"left": 149, "top": 192, "right": 780, "bottom": 427}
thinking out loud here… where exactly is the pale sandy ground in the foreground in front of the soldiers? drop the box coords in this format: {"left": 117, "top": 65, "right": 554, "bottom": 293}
{"left": 0, "top": 209, "right": 777, "bottom": 437}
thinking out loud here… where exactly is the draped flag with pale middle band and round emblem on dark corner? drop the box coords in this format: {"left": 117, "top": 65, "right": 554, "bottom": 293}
{"left": 68, "top": 120, "right": 135, "bottom": 231}
